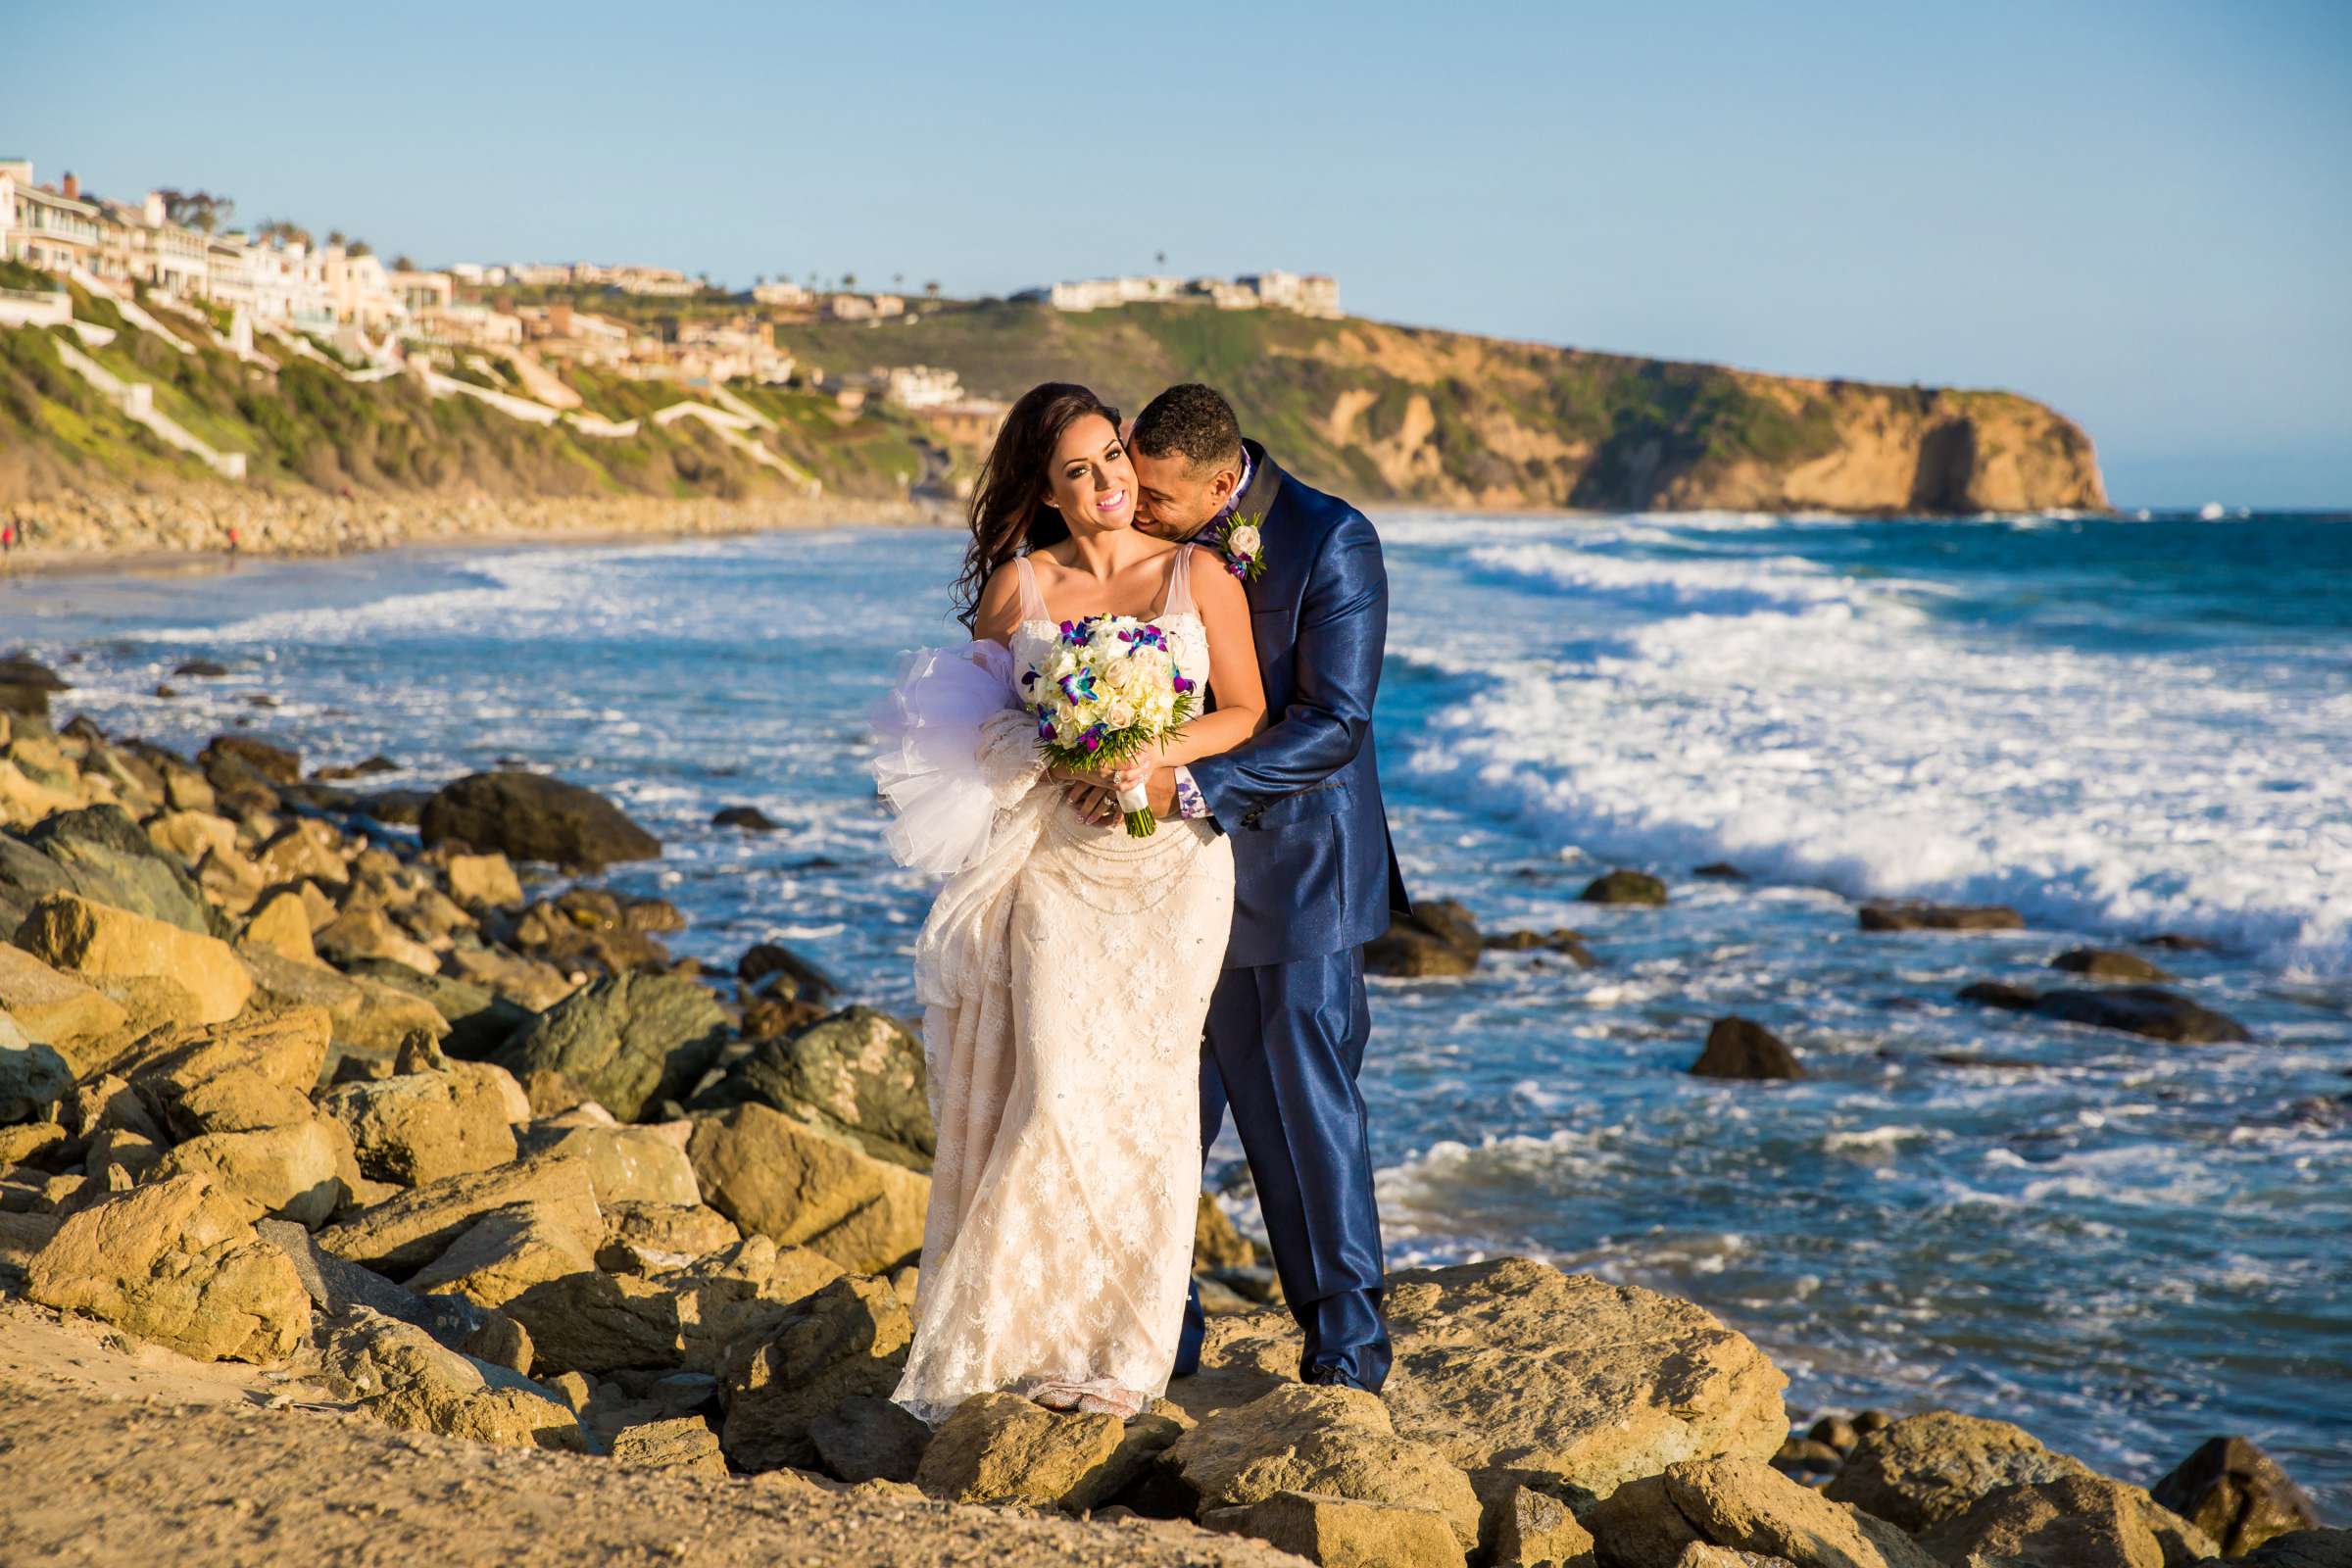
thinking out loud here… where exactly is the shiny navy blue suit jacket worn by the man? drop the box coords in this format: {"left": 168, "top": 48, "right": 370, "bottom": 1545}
{"left": 1193, "top": 442, "right": 1409, "bottom": 968}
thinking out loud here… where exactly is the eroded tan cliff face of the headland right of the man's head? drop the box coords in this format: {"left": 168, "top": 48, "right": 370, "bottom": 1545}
{"left": 1237, "top": 322, "right": 2107, "bottom": 513}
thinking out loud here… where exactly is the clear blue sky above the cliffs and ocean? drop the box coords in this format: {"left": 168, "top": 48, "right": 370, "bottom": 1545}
{"left": 0, "top": 0, "right": 2352, "bottom": 506}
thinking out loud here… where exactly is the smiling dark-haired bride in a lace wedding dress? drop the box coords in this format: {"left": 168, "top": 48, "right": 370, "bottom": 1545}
{"left": 875, "top": 383, "right": 1265, "bottom": 1422}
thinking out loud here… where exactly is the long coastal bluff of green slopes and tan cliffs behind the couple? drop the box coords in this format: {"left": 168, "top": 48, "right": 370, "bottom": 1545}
{"left": 0, "top": 268, "right": 2107, "bottom": 526}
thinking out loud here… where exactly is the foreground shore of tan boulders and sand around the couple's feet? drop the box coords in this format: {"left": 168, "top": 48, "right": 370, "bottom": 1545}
{"left": 0, "top": 676, "right": 2352, "bottom": 1568}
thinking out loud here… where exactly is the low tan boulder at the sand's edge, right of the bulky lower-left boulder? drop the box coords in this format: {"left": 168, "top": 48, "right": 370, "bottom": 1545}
{"left": 319, "top": 1307, "right": 590, "bottom": 1452}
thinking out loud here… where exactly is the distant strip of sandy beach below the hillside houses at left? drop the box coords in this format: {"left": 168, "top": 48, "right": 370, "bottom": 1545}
{"left": 0, "top": 487, "right": 941, "bottom": 576}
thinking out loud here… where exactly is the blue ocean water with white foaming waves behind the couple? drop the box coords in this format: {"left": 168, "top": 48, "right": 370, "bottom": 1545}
{"left": 0, "top": 513, "right": 2352, "bottom": 1523}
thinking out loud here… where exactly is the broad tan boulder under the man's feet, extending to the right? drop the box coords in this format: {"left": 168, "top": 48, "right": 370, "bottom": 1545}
{"left": 1195, "top": 1257, "right": 1788, "bottom": 1499}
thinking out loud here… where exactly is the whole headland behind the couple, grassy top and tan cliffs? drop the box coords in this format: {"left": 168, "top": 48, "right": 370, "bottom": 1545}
{"left": 776, "top": 303, "right": 2105, "bottom": 511}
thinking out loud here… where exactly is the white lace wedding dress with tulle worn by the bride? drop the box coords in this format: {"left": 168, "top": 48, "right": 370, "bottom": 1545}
{"left": 877, "top": 548, "right": 1233, "bottom": 1422}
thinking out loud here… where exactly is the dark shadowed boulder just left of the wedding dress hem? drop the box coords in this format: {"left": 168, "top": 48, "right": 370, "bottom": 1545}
{"left": 719, "top": 1274, "right": 915, "bottom": 1469}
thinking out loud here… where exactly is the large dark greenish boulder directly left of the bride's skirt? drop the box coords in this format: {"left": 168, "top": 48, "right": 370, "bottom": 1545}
{"left": 724, "top": 1006, "right": 939, "bottom": 1171}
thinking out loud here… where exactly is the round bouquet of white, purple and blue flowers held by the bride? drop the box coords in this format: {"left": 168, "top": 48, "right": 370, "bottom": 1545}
{"left": 1021, "top": 615, "right": 1200, "bottom": 839}
